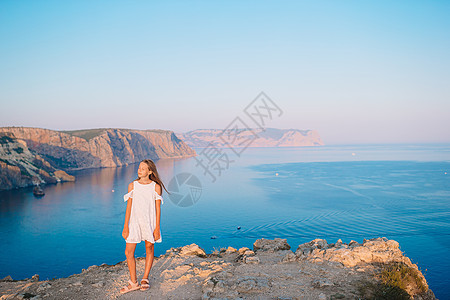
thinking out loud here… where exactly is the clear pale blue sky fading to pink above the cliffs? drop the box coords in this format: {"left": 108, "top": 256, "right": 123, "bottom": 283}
{"left": 0, "top": 0, "right": 450, "bottom": 145}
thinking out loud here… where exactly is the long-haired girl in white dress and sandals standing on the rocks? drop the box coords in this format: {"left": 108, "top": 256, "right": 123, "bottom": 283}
{"left": 120, "top": 159, "right": 168, "bottom": 293}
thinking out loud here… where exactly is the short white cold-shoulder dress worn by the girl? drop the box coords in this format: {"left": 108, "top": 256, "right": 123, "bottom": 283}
{"left": 123, "top": 180, "right": 164, "bottom": 244}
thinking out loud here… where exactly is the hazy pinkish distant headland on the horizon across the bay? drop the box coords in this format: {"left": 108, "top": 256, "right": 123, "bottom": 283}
{"left": 177, "top": 128, "right": 324, "bottom": 147}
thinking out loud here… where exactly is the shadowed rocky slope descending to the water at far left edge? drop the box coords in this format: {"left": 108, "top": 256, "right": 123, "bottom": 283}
{"left": 0, "top": 132, "right": 75, "bottom": 190}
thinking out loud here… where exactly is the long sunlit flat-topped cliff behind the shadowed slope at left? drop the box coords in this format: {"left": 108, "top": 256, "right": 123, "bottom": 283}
{"left": 0, "top": 127, "right": 196, "bottom": 170}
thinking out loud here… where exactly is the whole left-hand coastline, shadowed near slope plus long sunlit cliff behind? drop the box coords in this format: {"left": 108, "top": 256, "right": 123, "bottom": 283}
{"left": 0, "top": 127, "right": 196, "bottom": 190}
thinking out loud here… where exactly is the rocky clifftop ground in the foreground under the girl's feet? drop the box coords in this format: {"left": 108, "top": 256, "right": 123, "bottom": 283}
{"left": 0, "top": 238, "right": 436, "bottom": 299}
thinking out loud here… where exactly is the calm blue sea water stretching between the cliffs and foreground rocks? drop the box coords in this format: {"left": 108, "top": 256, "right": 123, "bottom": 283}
{"left": 0, "top": 145, "right": 450, "bottom": 299}
